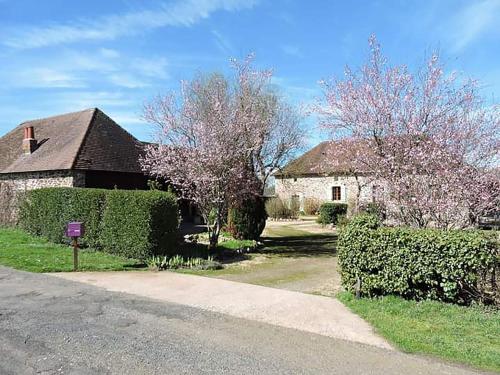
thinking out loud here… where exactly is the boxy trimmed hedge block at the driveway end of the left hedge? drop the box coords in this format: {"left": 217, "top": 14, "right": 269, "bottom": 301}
{"left": 101, "top": 190, "right": 179, "bottom": 259}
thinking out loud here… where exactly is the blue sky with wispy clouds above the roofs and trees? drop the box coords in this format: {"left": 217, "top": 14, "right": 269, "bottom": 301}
{"left": 0, "top": 0, "right": 500, "bottom": 143}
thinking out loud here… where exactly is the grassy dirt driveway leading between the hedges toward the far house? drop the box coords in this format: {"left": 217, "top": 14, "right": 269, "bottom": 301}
{"left": 197, "top": 220, "right": 340, "bottom": 296}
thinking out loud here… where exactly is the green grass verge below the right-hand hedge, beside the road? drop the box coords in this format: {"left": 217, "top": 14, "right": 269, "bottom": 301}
{"left": 338, "top": 292, "right": 500, "bottom": 371}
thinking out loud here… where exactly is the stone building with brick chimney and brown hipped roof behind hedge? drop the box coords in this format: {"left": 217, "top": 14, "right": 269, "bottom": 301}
{"left": 0, "top": 108, "right": 147, "bottom": 191}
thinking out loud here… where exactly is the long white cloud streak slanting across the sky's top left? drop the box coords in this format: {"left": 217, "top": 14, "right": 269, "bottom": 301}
{"left": 0, "top": 0, "right": 257, "bottom": 49}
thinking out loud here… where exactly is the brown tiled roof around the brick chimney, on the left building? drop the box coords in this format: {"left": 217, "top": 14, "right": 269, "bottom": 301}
{"left": 0, "top": 108, "right": 143, "bottom": 173}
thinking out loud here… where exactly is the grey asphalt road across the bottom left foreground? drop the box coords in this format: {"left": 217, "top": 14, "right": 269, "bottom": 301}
{"left": 0, "top": 267, "right": 490, "bottom": 375}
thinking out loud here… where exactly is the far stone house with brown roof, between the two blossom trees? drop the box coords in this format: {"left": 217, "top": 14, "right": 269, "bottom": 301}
{"left": 274, "top": 141, "right": 380, "bottom": 211}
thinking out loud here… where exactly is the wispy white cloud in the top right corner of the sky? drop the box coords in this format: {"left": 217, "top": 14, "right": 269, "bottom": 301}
{"left": 443, "top": 0, "right": 500, "bottom": 52}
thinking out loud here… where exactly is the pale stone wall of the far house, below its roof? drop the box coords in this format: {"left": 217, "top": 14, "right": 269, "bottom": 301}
{"left": 275, "top": 175, "right": 374, "bottom": 214}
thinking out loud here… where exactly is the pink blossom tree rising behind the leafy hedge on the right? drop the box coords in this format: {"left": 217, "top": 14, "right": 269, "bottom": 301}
{"left": 317, "top": 37, "right": 500, "bottom": 228}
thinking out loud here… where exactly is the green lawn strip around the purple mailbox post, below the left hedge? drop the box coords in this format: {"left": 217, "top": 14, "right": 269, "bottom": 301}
{"left": 0, "top": 228, "right": 145, "bottom": 272}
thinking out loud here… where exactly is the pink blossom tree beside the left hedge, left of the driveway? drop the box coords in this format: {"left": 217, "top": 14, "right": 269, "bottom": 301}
{"left": 142, "top": 56, "right": 299, "bottom": 248}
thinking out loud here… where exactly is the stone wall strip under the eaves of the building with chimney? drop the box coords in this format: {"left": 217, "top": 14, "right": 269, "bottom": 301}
{"left": 0, "top": 170, "right": 85, "bottom": 191}
